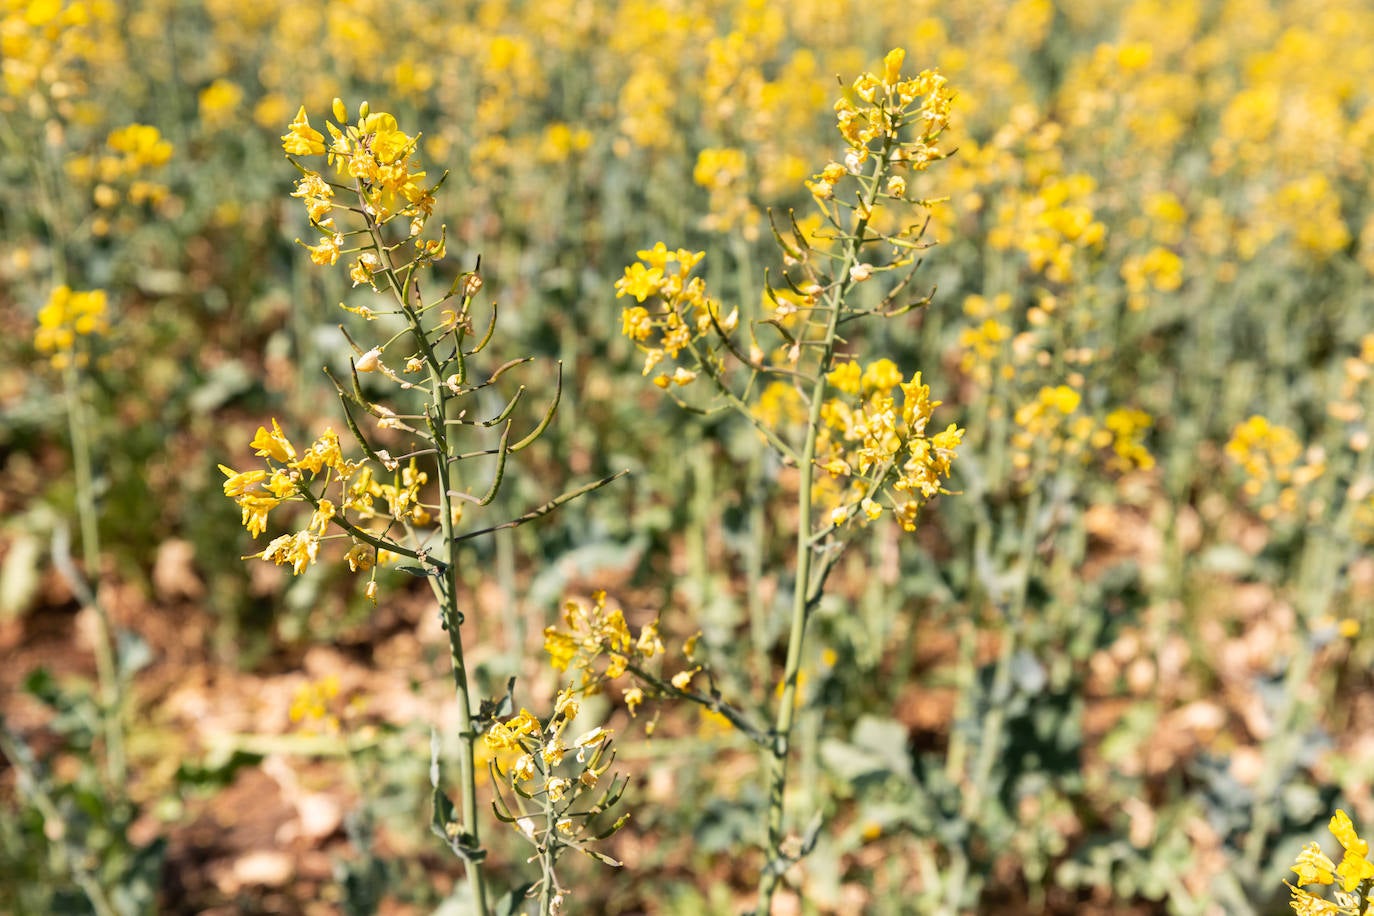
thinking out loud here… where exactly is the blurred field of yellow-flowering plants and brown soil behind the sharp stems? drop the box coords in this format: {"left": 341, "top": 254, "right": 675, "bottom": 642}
{"left": 0, "top": 0, "right": 1374, "bottom": 913}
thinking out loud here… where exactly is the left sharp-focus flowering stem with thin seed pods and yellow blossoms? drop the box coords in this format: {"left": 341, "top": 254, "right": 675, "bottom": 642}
{"left": 221, "top": 100, "right": 620, "bottom": 915}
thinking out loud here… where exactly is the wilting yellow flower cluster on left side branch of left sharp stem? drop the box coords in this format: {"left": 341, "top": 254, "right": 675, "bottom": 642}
{"left": 220, "top": 420, "right": 414, "bottom": 579}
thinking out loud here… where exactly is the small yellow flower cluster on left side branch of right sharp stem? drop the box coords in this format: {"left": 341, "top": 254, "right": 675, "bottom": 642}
{"left": 616, "top": 242, "right": 739, "bottom": 389}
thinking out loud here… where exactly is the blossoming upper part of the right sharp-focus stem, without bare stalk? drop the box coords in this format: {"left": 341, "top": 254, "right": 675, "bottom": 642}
{"left": 616, "top": 48, "right": 963, "bottom": 531}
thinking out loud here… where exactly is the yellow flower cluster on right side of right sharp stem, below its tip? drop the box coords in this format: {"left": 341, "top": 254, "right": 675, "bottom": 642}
{"left": 816, "top": 358, "right": 965, "bottom": 531}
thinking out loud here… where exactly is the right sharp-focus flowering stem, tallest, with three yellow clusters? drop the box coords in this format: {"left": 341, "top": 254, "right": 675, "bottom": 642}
{"left": 617, "top": 48, "right": 963, "bottom": 913}
